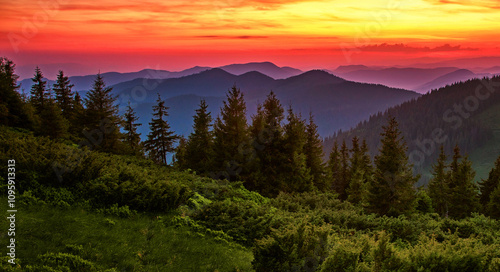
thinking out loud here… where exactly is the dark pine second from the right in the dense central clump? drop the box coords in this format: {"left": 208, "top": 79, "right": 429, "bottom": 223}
{"left": 282, "top": 107, "right": 313, "bottom": 192}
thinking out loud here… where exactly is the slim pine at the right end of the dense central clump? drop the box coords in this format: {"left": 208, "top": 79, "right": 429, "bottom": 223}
{"left": 304, "top": 113, "right": 326, "bottom": 190}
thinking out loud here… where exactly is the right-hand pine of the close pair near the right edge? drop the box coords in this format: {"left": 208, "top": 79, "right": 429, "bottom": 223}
{"left": 449, "top": 146, "right": 479, "bottom": 218}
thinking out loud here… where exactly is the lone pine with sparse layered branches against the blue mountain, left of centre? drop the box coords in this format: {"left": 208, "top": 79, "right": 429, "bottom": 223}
{"left": 144, "top": 94, "right": 179, "bottom": 164}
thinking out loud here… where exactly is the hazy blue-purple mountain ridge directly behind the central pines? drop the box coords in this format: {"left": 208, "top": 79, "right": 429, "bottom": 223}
{"left": 112, "top": 69, "right": 419, "bottom": 136}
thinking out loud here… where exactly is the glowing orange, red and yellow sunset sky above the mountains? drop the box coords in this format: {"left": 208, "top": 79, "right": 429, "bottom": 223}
{"left": 0, "top": 0, "right": 500, "bottom": 78}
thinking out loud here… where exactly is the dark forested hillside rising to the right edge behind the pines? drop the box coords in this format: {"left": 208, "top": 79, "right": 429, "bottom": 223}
{"left": 324, "top": 76, "right": 500, "bottom": 182}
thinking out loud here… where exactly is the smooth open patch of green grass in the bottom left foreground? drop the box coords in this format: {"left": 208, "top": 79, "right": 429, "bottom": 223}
{"left": 0, "top": 198, "right": 253, "bottom": 271}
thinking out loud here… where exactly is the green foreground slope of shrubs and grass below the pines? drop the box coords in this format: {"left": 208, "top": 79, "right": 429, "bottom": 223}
{"left": 0, "top": 126, "right": 500, "bottom": 272}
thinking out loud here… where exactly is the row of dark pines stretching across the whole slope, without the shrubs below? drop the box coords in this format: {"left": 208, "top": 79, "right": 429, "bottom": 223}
{"left": 0, "top": 58, "right": 500, "bottom": 218}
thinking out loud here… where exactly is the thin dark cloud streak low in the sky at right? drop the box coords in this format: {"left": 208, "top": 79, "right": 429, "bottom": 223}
{"left": 358, "top": 43, "right": 479, "bottom": 53}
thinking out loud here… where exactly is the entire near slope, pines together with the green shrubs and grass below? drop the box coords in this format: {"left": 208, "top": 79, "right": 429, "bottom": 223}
{"left": 0, "top": 58, "right": 500, "bottom": 271}
